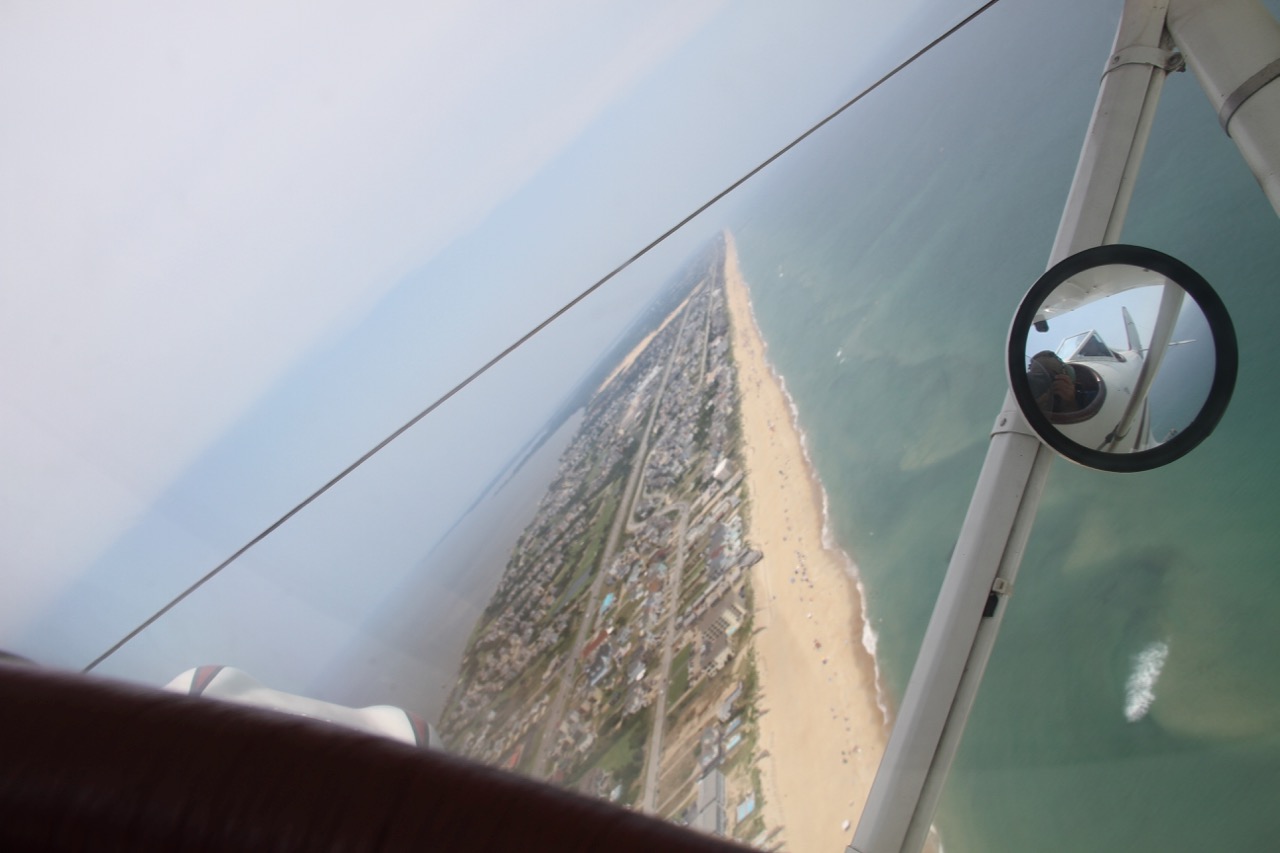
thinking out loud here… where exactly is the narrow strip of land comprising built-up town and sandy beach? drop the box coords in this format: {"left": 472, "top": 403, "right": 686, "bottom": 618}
{"left": 439, "top": 232, "right": 888, "bottom": 850}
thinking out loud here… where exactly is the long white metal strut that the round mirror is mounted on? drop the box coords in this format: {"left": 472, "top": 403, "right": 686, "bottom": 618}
{"left": 846, "top": 0, "right": 1179, "bottom": 853}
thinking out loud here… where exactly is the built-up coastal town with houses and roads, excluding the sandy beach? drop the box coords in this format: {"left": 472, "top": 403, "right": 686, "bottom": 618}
{"left": 442, "top": 234, "right": 769, "bottom": 845}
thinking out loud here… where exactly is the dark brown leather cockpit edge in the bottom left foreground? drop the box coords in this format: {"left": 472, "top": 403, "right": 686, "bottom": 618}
{"left": 0, "top": 663, "right": 745, "bottom": 853}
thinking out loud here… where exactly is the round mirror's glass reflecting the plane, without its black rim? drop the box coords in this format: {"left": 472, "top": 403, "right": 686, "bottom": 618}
{"left": 1025, "top": 272, "right": 1215, "bottom": 453}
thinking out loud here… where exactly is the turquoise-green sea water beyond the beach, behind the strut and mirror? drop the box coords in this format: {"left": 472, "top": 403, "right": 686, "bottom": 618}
{"left": 733, "top": 1, "right": 1280, "bottom": 853}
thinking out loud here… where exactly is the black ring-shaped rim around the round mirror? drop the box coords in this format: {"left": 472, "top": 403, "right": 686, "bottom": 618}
{"left": 1005, "top": 243, "right": 1239, "bottom": 473}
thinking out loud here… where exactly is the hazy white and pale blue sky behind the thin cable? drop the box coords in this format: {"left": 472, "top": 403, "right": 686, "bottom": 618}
{"left": 0, "top": 0, "right": 977, "bottom": 666}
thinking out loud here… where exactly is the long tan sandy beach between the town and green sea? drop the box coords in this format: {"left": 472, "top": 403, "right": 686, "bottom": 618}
{"left": 724, "top": 234, "right": 887, "bottom": 853}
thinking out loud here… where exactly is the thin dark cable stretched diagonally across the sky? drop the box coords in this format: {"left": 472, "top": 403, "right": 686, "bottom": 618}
{"left": 83, "top": 0, "right": 1000, "bottom": 672}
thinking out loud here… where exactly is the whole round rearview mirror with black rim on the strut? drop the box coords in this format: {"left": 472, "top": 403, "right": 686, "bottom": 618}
{"left": 1007, "top": 245, "right": 1239, "bottom": 471}
